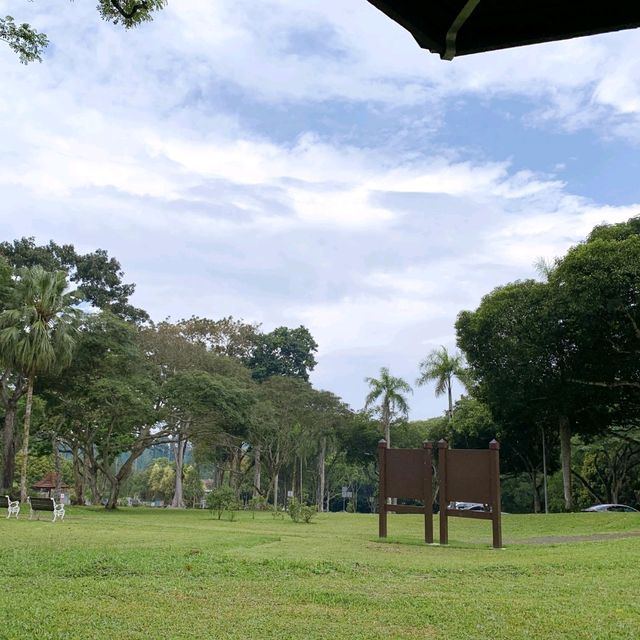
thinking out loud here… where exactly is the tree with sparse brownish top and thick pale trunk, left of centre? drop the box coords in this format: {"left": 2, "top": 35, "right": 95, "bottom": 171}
{"left": 140, "top": 317, "right": 255, "bottom": 506}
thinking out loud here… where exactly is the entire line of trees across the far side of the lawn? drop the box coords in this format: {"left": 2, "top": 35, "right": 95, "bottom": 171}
{"left": 0, "top": 218, "right": 640, "bottom": 511}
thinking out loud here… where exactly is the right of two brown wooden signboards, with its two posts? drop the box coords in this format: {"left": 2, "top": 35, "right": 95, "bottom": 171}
{"left": 438, "top": 440, "right": 502, "bottom": 549}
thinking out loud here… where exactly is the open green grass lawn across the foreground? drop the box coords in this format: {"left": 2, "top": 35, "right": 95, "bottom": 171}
{"left": 0, "top": 508, "right": 640, "bottom": 640}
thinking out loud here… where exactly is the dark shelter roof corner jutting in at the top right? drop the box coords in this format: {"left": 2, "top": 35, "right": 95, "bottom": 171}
{"left": 369, "top": 0, "right": 640, "bottom": 60}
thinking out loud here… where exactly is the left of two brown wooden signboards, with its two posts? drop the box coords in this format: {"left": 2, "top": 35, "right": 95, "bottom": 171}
{"left": 378, "top": 440, "right": 433, "bottom": 543}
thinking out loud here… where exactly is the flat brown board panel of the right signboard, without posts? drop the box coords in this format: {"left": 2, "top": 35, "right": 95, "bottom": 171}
{"left": 447, "top": 449, "right": 492, "bottom": 504}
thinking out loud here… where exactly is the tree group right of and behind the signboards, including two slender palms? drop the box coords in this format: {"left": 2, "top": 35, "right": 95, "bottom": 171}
{"left": 350, "top": 217, "right": 640, "bottom": 512}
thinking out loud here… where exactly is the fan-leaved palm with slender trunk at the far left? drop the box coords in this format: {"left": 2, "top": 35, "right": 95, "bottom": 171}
{"left": 0, "top": 266, "right": 77, "bottom": 501}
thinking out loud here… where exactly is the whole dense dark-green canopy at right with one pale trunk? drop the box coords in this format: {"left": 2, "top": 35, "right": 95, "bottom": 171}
{"left": 456, "top": 218, "right": 640, "bottom": 509}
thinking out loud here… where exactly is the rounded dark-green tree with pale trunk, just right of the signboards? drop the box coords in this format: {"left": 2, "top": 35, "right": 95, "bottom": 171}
{"left": 456, "top": 280, "right": 611, "bottom": 510}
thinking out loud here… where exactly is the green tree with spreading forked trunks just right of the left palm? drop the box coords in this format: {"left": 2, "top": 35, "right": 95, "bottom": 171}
{"left": 47, "top": 312, "right": 158, "bottom": 508}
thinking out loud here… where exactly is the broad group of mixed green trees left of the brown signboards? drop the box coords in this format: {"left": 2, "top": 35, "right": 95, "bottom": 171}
{"left": 0, "top": 238, "right": 370, "bottom": 510}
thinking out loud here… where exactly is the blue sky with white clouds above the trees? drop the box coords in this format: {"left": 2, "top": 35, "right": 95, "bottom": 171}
{"left": 0, "top": 0, "right": 640, "bottom": 419}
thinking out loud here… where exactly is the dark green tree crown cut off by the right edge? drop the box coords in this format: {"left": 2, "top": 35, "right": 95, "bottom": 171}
{"left": 549, "top": 217, "right": 640, "bottom": 402}
